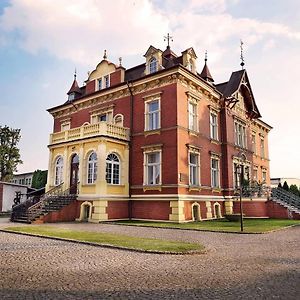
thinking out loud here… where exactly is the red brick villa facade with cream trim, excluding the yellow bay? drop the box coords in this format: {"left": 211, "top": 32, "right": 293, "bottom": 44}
{"left": 49, "top": 46, "right": 284, "bottom": 221}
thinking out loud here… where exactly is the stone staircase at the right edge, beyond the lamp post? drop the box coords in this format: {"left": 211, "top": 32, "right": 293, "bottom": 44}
{"left": 270, "top": 187, "right": 300, "bottom": 216}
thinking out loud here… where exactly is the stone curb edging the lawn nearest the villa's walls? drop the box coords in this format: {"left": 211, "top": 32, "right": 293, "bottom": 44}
{"left": 106, "top": 222, "right": 300, "bottom": 235}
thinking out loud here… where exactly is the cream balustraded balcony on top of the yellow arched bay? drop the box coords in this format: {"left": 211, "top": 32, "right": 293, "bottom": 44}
{"left": 50, "top": 122, "right": 129, "bottom": 145}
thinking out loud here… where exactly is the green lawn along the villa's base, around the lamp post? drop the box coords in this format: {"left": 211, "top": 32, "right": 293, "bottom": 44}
{"left": 115, "top": 219, "right": 300, "bottom": 233}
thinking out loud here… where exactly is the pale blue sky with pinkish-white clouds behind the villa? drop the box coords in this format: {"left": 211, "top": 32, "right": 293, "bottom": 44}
{"left": 0, "top": 0, "right": 300, "bottom": 178}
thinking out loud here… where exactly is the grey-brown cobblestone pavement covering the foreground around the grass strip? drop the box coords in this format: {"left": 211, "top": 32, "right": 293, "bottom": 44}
{"left": 0, "top": 218, "right": 300, "bottom": 300}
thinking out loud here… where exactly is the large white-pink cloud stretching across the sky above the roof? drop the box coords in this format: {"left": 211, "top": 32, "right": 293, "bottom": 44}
{"left": 0, "top": 0, "right": 300, "bottom": 70}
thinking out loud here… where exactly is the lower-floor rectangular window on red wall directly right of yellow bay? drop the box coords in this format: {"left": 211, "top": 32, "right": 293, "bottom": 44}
{"left": 145, "top": 152, "right": 161, "bottom": 185}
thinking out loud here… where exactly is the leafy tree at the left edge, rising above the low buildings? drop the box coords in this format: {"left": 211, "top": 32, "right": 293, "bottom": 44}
{"left": 0, "top": 125, "right": 23, "bottom": 181}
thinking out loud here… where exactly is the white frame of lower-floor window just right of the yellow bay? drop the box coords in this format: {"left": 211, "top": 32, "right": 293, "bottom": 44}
{"left": 144, "top": 149, "right": 162, "bottom": 186}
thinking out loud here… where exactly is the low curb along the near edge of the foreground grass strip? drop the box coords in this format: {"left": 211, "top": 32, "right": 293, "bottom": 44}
{"left": 0, "top": 229, "right": 207, "bottom": 255}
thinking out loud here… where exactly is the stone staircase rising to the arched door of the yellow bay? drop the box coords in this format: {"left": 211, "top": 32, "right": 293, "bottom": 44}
{"left": 11, "top": 184, "right": 77, "bottom": 224}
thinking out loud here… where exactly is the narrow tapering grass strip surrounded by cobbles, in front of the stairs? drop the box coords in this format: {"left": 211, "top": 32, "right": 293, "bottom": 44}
{"left": 5, "top": 225, "right": 204, "bottom": 253}
